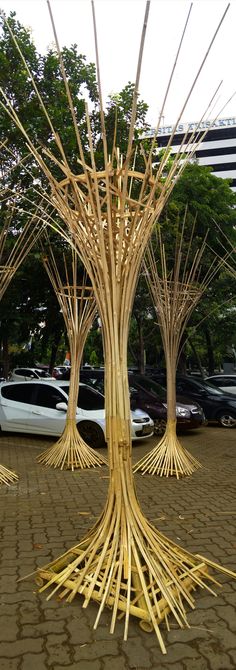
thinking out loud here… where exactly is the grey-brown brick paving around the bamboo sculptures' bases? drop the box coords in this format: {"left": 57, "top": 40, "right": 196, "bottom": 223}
{"left": 0, "top": 427, "right": 236, "bottom": 670}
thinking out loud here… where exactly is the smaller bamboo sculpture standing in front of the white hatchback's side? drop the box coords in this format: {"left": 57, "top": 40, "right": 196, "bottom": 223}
{"left": 37, "top": 235, "right": 107, "bottom": 470}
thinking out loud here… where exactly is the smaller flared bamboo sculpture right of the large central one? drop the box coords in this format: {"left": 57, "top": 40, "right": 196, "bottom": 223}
{"left": 134, "top": 215, "right": 223, "bottom": 478}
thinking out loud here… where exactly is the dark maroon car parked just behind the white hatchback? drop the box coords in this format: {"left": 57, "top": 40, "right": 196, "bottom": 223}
{"left": 80, "top": 370, "right": 205, "bottom": 435}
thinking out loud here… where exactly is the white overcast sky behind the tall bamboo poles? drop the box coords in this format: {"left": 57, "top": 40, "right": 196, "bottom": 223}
{"left": 0, "top": 0, "right": 236, "bottom": 125}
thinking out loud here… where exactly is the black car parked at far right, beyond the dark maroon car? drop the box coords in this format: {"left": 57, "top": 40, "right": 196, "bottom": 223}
{"left": 172, "top": 375, "right": 236, "bottom": 428}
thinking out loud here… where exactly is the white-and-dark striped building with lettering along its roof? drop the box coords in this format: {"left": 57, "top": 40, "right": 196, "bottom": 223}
{"left": 145, "top": 117, "right": 236, "bottom": 191}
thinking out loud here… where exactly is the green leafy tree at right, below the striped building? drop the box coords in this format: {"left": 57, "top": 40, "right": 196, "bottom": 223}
{"left": 149, "top": 163, "right": 236, "bottom": 372}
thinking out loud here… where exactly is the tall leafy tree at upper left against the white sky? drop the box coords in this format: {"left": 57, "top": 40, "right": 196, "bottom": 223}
{"left": 0, "top": 12, "right": 97, "bottom": 170}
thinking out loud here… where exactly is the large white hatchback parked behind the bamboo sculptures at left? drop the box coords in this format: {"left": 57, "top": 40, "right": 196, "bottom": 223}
{"left": 0, "top": 380, "right": 154, "bottom": 448}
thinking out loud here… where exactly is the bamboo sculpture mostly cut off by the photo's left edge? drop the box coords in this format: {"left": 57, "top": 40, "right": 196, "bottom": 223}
{"left": 0, "top": 202, "right": 44, "bottom": 485}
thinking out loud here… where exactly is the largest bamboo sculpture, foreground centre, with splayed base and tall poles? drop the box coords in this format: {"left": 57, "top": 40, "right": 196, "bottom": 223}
{"left": 0, "top": 3, "right": 235, "bottom": 653}
